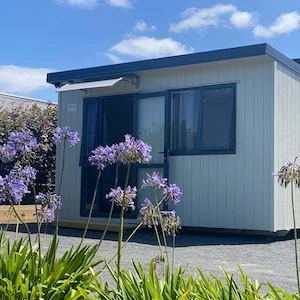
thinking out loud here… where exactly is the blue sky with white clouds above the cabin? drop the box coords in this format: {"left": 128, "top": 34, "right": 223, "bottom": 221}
{"left": 0, "top": 0, "right": 300, "bottom": 101}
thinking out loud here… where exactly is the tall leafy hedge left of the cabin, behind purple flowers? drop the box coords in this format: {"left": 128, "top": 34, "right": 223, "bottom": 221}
{"left": 0, "top": 104, "right": 57, "bottom": 203}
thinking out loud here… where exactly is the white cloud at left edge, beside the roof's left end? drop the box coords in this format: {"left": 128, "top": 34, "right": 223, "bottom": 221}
{"left": 0, "top": 65, "right": 55, "bottom": 94}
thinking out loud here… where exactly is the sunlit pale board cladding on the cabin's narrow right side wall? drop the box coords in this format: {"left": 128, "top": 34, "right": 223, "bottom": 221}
{"left": 274, "top": 63, "right": 300, "bottom": 230}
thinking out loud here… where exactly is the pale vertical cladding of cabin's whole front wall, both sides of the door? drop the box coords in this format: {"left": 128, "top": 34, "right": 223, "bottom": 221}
{"left": 58, "top": 57, "right": 274, "bottom": 231}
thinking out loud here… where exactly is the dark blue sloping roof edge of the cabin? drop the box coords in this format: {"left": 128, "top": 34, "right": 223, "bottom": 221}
{"left": 47, "top": 43, "right": 300, "bottom": 87}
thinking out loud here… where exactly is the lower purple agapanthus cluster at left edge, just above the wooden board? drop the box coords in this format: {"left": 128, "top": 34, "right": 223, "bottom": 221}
{"left": 0, "top": 166, "right": 36, "bottom": 204}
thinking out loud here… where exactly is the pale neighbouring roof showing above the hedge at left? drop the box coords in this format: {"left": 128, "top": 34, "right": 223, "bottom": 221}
{"left": 0, "top": 93, "right": 57, "bottom": 107}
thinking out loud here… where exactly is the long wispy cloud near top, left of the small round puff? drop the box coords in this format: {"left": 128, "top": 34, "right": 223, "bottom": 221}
{"left": 170, "top": 4, "right": 237, "bottom": 33}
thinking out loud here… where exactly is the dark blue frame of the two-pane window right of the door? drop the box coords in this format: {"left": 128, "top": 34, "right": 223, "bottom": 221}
{"left": 166, "top": 83, "right": 236, "bottom": 156}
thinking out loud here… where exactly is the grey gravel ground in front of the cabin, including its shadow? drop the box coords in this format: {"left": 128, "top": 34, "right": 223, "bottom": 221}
{"left": 3, "top": 228, "right": 300, "bottom": 292}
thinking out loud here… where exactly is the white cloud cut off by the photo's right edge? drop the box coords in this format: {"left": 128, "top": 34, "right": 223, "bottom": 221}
{"left": 253, "top": 11, "right": 300, "bottom": 38}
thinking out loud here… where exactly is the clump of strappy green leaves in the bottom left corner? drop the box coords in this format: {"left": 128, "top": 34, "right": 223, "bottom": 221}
{"left": 0, "top": 232, "right": 99, "bottom": 300}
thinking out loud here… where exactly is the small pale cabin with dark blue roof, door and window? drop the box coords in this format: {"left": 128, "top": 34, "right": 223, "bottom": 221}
{"left": 47, "top": 44, "right": 300, "bottom": 232}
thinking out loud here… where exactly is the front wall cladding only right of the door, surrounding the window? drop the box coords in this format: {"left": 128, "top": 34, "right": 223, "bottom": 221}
{"left": 170, "top": 59, "right": 274, "bottom": 231}
